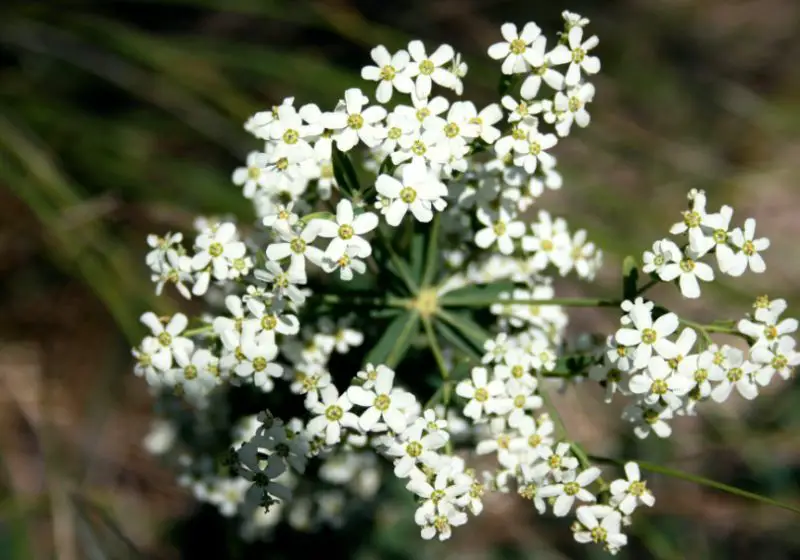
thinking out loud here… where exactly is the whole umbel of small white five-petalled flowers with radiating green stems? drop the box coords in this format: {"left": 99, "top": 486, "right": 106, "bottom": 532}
{"left": 133, "top": 12, "right": 800, "bottom": 553}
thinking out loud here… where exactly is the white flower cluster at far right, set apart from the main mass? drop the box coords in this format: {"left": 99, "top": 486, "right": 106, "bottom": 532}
{"left": 590, "top": 191, "right": 800, "bottom": 438}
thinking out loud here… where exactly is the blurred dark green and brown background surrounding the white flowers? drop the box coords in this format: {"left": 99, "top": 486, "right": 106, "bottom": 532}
{"left": 0, "top": 0, "right": 800, "bottom": 559}
